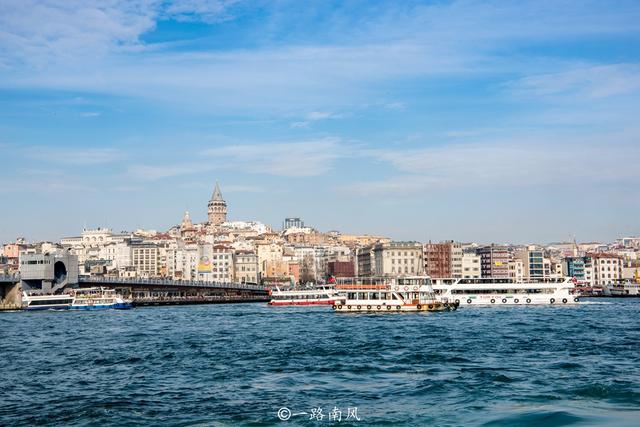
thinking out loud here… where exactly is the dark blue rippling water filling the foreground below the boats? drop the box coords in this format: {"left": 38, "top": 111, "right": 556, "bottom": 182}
{"left": 0, "top": 300, "right": 640, "bottom": 426}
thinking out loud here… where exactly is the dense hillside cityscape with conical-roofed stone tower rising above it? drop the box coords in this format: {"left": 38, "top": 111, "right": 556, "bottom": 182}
{"left": 0, "top": 183, "right": 640, "bottom": 287}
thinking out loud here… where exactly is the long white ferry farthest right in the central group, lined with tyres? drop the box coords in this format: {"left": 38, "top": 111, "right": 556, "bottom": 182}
{"left": 432, "top": 277, "right": 580, "bottom": 305}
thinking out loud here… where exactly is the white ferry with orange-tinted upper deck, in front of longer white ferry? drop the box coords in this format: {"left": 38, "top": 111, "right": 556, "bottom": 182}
{"left": 333, "top": 276, "right": 459, "bottom": 313}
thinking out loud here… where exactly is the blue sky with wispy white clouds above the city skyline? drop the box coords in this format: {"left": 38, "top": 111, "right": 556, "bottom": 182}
{"left": 0, "top": 0, "right": 640, "bottom": 242}
